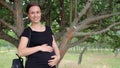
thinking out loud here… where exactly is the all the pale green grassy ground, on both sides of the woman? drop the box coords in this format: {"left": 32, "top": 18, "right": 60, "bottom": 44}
{"left": 0, "top": 51, "right": 120, "bottom": 68}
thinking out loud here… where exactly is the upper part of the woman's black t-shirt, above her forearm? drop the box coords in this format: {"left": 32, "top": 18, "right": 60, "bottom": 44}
{"left": 21, "top": 26, "right": 53, "bottom": 47}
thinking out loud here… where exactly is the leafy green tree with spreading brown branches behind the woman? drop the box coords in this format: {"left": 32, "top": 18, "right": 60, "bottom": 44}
{"left": 0, "top": 0, "right": 120, "bottom": 66}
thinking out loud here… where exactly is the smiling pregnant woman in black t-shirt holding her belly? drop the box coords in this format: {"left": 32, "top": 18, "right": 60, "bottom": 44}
{"left": 18, "top": 3, "right": 60, "bottom": 68}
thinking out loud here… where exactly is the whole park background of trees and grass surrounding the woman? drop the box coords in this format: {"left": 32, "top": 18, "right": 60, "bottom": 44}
{"left": 0, "top": 0, "right": 120, "bottom": 68}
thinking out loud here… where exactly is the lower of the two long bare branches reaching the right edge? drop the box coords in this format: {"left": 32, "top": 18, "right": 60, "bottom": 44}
{"left": 74, "top": 22, "right": 120, "bottom": 36}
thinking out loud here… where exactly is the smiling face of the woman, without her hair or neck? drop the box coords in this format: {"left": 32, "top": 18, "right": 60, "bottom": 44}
{"left": 28, "top": 6, "right": 41, "bottom": 23}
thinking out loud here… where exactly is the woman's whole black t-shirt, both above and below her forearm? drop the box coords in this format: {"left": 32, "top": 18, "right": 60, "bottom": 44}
{"left": 21, "top": 26, "right": 55, "bottom": 68}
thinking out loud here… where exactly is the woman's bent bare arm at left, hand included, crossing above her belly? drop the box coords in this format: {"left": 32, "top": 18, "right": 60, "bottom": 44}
{"left": 18, "top": 37, "right": 53, "bottom": 56}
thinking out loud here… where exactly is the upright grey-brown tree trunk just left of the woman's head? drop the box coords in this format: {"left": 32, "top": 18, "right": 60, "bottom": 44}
{"left": 14, "top": 0, "right": 24, "bottom": 38}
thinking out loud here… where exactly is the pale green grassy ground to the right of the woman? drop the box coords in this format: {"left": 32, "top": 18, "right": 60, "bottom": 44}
{"left": 60, "top": 51, "right": 120, "bottom": 68}
